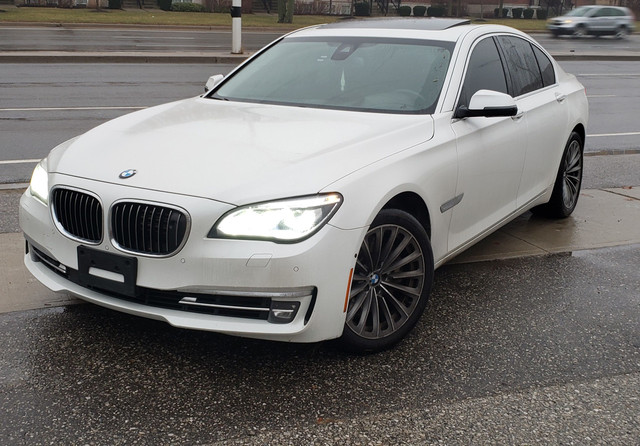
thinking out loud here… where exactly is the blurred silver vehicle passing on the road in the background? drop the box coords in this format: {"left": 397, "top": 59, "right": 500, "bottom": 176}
{"left": 547, "top": 5, "right": 636, "bottom": 39}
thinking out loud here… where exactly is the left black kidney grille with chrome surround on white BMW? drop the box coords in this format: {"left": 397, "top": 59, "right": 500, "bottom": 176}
{"left": 51, "top": 188, "right": 102, "bottom": 243}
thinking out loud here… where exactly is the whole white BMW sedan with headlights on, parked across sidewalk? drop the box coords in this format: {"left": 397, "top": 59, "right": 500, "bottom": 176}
{"left": 20, "top": 19, "right": 588, "bottom": 351}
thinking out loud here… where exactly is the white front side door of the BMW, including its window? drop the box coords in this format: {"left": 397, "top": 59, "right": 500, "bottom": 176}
{"left": 449, "top": 37, "right": 527, "bottom": 250}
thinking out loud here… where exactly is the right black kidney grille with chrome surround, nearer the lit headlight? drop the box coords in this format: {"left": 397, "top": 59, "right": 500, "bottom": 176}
{"left": 111, "top": 201, "right": 188, "bottom": 256}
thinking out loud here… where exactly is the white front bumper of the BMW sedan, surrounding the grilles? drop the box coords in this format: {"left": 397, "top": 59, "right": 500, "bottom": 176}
{"left": 20, "top": 175, "right": 366, "bottom": 342}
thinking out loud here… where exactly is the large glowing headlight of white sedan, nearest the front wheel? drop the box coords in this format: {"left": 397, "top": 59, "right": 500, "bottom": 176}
{"left": 209, "top": 193, "right": 342, "bottom": 243}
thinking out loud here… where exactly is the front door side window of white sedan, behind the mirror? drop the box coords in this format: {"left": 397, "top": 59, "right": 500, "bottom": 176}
{"left": 458, "top": 38, "right": 507, "bottom": 105}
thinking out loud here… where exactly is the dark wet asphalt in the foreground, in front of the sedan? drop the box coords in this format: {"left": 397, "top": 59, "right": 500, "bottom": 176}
{"left": 0, "top": 246, "right": 640, "bottom": 445}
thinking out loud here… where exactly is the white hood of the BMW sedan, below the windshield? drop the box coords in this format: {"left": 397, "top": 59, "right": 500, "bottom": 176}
{"left": 49, "top": 98, "right": 433, "bottom": 205}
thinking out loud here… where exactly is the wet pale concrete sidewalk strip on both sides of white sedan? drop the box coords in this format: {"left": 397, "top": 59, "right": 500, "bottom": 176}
{"left": 0, "top": 187, "right": 640, "bottom": 313}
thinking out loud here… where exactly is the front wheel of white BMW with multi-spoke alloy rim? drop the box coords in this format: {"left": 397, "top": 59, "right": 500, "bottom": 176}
{"left": 339, "top": 209, "right": 434, "bottom": 353}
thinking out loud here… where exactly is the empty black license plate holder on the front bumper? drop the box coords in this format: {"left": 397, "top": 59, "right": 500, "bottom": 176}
{"left": 78, "top": 246, "right": 138, "bottom": 297}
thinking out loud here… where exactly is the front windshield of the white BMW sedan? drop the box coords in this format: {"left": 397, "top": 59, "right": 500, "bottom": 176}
{"left": 210, "top": 37, "right": 453, "bottom": 113}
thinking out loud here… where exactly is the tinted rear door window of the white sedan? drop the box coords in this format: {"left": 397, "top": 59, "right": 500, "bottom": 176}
{"left": 498, "top": 36, "right": 543, "bottom": 97}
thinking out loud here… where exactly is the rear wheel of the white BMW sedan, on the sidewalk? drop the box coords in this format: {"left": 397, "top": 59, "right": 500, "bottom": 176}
{"left": 532, "top": 132, "right": 584, "bottom": 218}
